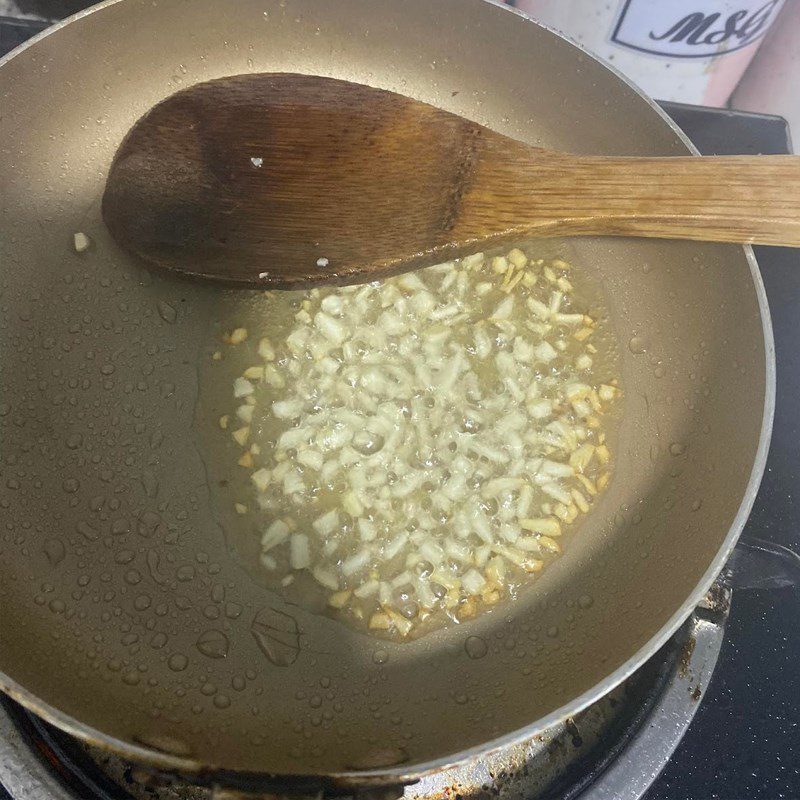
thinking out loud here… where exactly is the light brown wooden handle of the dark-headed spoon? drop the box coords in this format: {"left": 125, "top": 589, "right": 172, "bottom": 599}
{"left": 466, "top": 147, "right": 800, "bottom": 247}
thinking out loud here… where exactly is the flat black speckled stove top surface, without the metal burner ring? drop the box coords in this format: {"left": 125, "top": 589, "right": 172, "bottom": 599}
{"left": 0, "top": 10, "right": 800, "bottom": 800}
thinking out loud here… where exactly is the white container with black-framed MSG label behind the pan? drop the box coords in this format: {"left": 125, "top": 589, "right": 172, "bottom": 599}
{"left": 512, "top": 0, "right": 784, "bottom": 106}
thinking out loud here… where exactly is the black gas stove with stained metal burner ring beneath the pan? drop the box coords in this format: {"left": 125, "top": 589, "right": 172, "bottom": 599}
{"left": 0, "top": 6, "right": 800, "bottom": 800}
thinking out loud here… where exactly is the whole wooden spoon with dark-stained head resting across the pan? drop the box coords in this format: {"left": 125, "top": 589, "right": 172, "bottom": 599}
{"left": 103, "top": 74, "right": 800, "bottom": 289}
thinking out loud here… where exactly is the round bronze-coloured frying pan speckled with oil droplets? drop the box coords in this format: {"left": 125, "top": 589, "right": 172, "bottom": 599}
{"left": 0, "top": 0, "right": 774, "bottom": 786}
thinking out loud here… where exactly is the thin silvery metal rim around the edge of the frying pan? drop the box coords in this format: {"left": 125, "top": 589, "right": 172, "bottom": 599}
{"left": 0, "top": 0, "right": 776, "bottom": 786}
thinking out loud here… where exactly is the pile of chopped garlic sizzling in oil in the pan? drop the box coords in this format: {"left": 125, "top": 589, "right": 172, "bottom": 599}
{"left": 220, "top": 249, "right": 619, "bottom": 637}
